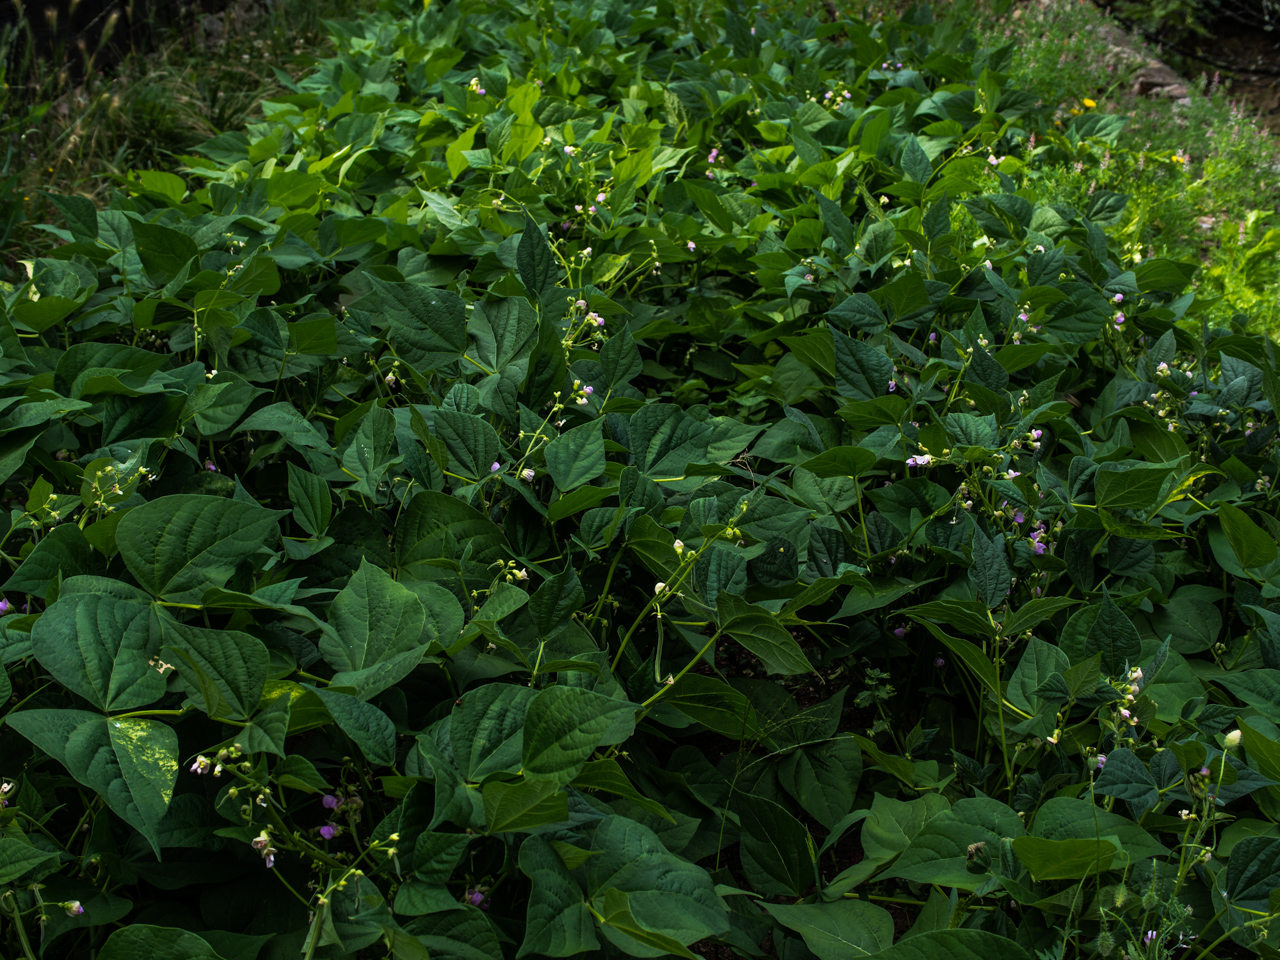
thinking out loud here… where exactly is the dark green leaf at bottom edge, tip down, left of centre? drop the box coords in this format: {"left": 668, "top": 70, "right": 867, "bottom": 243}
{"left": 516, "top": 836, "right": 600, "bottom": 957}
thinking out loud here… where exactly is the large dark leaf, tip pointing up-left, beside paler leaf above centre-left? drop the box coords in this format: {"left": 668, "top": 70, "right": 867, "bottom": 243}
{"left": 369, "top": 275, "right": 467, "bottom": 374}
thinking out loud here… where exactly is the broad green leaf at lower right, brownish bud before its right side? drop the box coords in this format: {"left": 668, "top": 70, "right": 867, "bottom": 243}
{"left": 884, "top": 796, "right": 1024, "bottom": 890}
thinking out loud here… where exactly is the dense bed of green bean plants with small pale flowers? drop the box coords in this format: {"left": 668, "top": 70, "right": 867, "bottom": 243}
{"left": 0, "top": 0, "right": 1280, "bottom": 960}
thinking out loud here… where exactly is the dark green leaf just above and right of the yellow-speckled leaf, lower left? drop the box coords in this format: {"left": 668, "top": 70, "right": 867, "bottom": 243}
{"left": 160, "top": 617, "right": 271, "bottom": 721}
